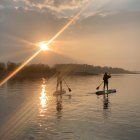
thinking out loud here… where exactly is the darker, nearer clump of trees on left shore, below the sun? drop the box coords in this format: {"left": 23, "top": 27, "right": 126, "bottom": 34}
{"left": 0, "top": 62, "right": 56, "bottom": 79}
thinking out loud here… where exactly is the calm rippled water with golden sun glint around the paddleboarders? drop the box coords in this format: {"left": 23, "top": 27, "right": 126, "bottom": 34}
{"left": 0, "top": 75, "right": 140, "bottom": 140}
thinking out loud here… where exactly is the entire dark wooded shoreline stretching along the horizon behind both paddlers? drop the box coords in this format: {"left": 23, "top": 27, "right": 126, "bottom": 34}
{"left": 0, "top": 62, "right": 133, "bottom": 78}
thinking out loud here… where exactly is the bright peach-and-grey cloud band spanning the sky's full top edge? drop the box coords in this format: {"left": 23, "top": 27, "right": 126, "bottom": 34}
{"left": 0, "top": 0, "right": 140, "bottom": 18}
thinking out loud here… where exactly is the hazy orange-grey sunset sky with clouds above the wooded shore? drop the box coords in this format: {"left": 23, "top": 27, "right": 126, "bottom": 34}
{"left": 0, "top": 0, "right": 140, "bottom": 71}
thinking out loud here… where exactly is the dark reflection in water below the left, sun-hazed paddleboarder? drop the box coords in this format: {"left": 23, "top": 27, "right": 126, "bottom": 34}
{"left": 56, "top": 95, "right": 63, "bottom": 119}
